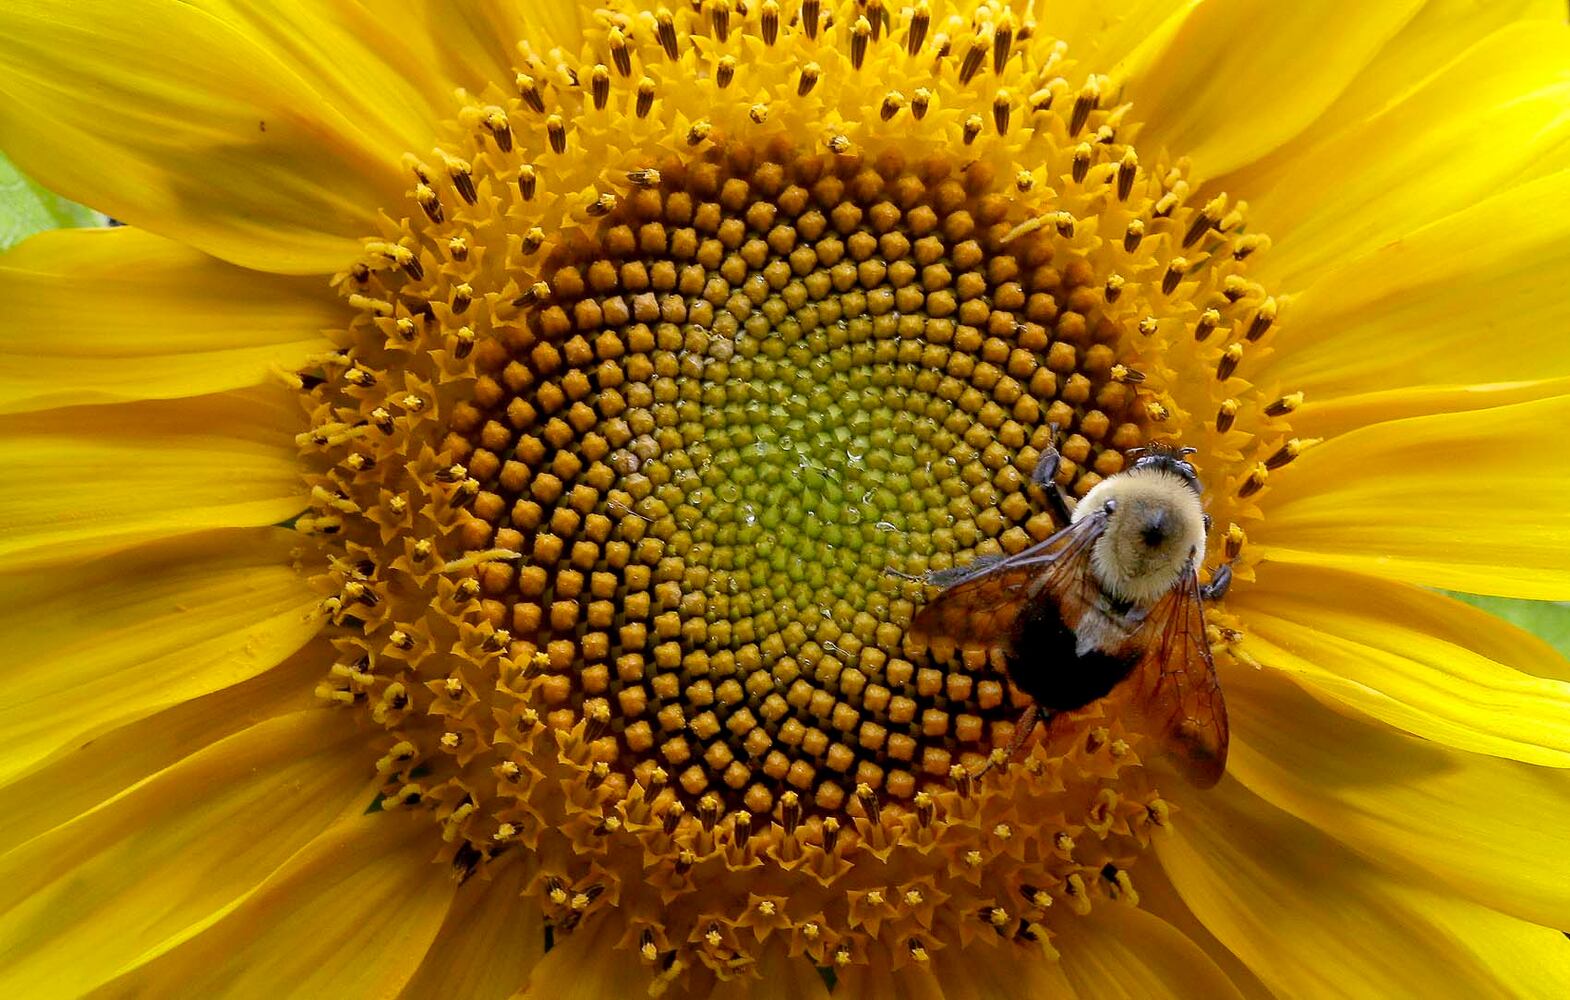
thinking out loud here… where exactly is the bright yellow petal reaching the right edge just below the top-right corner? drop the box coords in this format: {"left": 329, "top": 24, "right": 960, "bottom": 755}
{"left": 1229, "top": 22, "right": 1570, "bottom": 289}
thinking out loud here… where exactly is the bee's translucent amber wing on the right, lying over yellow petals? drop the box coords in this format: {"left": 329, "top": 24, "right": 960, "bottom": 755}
{"left": 1130, "top": 570, "right": 1228, "bottom": 788}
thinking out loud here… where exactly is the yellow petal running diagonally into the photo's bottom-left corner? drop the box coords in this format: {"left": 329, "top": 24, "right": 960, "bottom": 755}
{"left": 0, "top": 708, "right": 373, "bottom": 997}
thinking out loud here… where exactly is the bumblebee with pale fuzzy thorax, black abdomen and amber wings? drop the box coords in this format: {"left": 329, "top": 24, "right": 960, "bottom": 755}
{"left": 911, "top": 446, "right": 1232, "bottom": 788}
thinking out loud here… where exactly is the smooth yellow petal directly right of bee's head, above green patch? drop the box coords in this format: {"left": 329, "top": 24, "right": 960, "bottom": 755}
{"left": 1253, "top": 396, "right": 1570, "bottom": 600}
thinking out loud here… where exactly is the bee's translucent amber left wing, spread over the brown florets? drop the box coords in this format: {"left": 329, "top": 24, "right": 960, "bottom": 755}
{"left": 911, "top": 512, "right": 1107, "bottom": 644}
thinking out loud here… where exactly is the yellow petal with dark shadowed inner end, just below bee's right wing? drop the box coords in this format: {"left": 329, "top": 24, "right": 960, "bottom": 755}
{"left": 1226, "top": 670, "right": 1570, "bottom": 926}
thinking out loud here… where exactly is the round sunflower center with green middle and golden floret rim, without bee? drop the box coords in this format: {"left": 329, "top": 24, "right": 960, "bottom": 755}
{"left": 300, "top": 0, "right": 1295, "bottom": 976}
